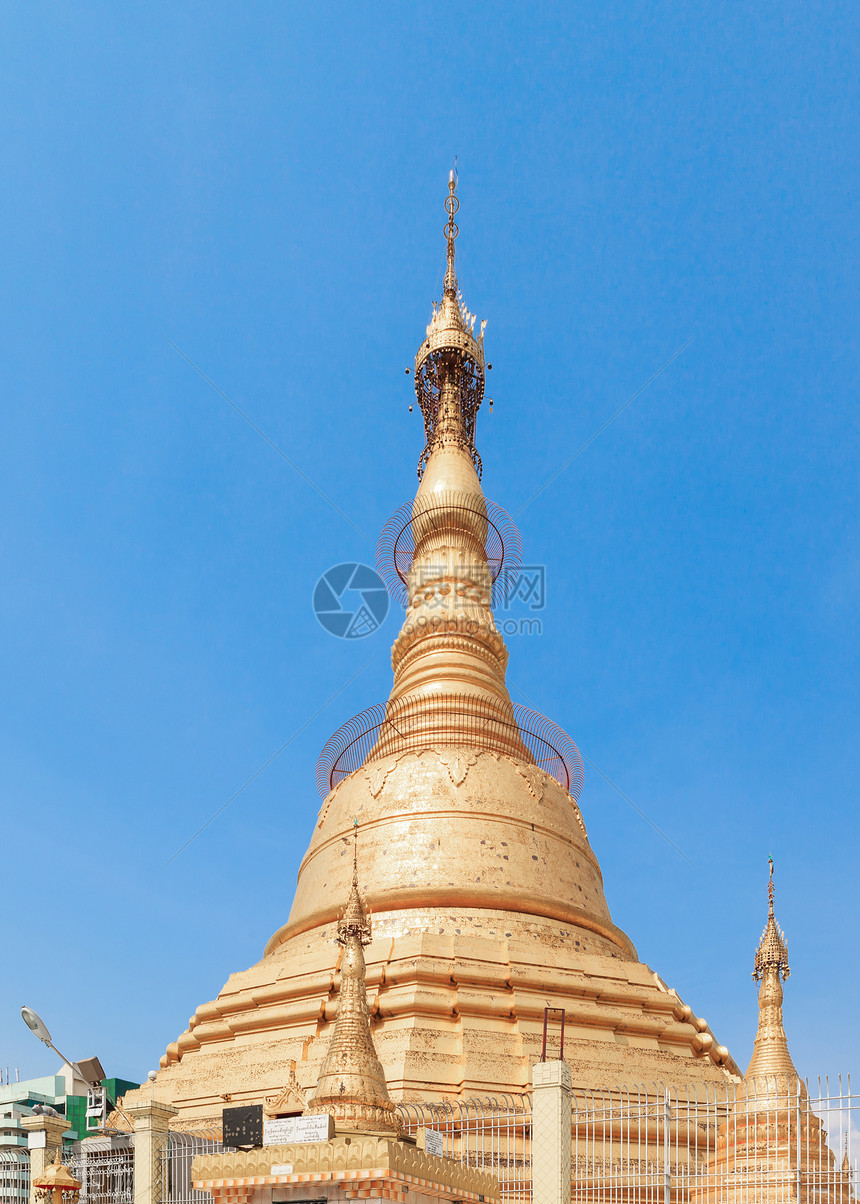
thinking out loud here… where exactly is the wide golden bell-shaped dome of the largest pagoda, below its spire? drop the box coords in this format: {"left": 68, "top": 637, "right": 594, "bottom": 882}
{"left": 266, "top": 744, "right": 636, "bottom": 960}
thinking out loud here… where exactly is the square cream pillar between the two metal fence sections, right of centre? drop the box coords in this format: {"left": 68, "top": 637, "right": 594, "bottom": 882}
{"left": 531, "top": 1062, "right": 571, "bottom": 1204}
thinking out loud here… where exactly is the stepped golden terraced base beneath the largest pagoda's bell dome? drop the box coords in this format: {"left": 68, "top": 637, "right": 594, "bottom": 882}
{"left": 126, "top": 909, "right": 741, "bottom": 1129}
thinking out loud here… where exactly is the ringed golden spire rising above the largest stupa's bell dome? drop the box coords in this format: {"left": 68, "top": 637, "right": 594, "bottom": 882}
{"left": 368, "top": 171, "right": 531, "bottom": 761}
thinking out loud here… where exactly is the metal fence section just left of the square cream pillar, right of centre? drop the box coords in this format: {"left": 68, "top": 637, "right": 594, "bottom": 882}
{"left": 397, "top": 1094, "right": 531, "bottom": 1204}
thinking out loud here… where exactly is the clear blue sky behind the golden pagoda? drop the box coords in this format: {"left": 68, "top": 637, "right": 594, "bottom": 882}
{"left": 0, "top": 0, "right": 860, "bottom": 1078}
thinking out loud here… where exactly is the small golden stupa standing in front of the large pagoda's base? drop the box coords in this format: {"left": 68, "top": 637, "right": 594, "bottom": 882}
{"left": 306, "top": 820, "right": 400, "bottom": 1135}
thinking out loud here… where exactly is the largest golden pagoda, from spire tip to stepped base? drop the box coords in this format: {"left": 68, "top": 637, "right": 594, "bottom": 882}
{"left": 125, "top": 173, "right": 740, "bottom": 1128}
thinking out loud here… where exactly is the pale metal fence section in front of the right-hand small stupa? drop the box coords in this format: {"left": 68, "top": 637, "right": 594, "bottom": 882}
{"left": 571, "top": 1079, "right": 860, "bottom": 1204}
